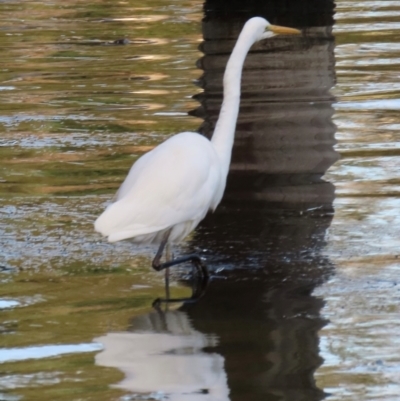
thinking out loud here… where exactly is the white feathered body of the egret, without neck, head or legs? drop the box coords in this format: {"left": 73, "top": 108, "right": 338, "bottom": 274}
{"left": 95, "top": 132, "right": 224, "bottom": 243}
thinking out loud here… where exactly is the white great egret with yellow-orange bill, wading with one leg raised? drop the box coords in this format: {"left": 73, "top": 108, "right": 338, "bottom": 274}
{"left": 95, "top": 17, "right": 301, "bottom": 276}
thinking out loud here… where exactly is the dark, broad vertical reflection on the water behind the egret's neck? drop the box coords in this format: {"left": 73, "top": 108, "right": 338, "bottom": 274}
{"left": 185, "top": 1, "right": 338, "bottom": 401}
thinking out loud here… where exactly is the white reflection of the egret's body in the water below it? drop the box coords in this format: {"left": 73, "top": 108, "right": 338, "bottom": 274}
{"left": 94, "top": 311, "right": 229, "bottom": 401}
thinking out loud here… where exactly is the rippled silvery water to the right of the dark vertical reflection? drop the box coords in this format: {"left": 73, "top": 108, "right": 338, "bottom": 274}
{"left": 316, "top": 1, "right": 400, "bottom": 400}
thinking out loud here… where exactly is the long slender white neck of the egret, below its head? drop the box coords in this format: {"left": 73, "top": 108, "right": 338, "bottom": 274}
{"left": 211, "top": 28, "right": 254, "bottom": 175}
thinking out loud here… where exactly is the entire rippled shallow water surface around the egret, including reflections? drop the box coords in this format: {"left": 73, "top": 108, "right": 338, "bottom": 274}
{"left": 0, "top": 0, "right": 400, "bottom": 401}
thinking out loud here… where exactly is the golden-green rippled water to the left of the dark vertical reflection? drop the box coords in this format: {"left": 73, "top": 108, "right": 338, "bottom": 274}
{"left": 0, "top": 1, "right": 205, "bottom": 401}
